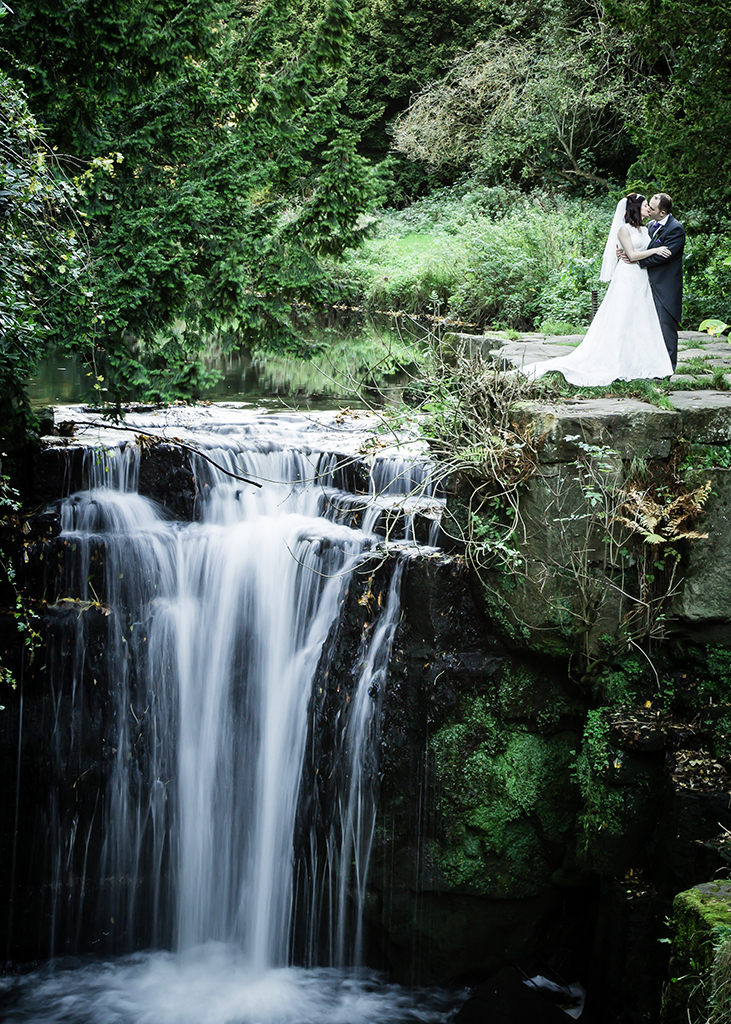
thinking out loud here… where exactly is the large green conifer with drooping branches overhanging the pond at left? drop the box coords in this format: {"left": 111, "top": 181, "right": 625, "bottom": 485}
{"left": 0, "top": 0, "right": 374, "bottom": 421}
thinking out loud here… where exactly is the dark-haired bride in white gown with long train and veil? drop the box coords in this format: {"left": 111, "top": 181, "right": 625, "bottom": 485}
{"left": 511, "top": 193, "right": 673, "bottom": 386}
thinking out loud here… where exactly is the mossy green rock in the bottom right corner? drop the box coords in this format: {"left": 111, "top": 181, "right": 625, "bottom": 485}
{"left": 661, "top": 882, "right": 731, "bottom": 1024}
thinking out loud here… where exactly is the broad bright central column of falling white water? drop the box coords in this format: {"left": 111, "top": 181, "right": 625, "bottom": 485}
{"left": 168, "top": 452, "right": 371, "bottom": 969}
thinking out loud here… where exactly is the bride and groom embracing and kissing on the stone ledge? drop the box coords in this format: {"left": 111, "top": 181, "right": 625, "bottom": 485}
{"left": 520, "top": 193, "right": 685, "bottom": 386}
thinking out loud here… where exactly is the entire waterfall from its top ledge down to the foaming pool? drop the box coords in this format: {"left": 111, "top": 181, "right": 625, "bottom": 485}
{"left": 0, "top": 406, "right": 461, "bottom": 1024}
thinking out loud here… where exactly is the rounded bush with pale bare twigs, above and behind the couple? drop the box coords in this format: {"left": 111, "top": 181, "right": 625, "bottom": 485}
{"left": 395, "top": 11, "right": 640, "bottom": 186}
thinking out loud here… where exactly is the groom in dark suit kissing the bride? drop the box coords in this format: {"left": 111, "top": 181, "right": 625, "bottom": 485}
{"left": 639, "top": 193, "right": 685, "bottom": 373}
